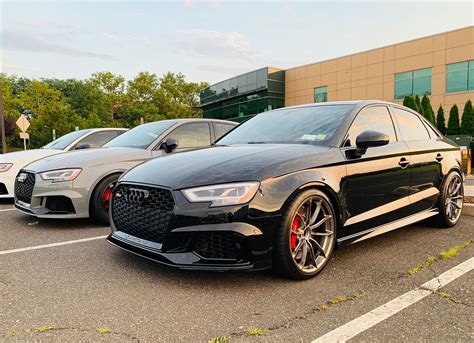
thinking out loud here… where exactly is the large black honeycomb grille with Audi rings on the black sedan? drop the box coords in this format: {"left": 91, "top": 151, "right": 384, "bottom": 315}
{"left": 112, "top": 184, "right": 175, "bottom": 243}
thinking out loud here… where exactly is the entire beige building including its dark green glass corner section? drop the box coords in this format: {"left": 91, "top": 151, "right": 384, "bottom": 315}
{"left": 201, "top": 26, "right": 474, "bottom": 121}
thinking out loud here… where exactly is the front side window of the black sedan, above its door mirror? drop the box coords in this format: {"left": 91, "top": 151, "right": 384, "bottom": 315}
{"left": 345, "top": 106, "right": 397, "bottom": 146}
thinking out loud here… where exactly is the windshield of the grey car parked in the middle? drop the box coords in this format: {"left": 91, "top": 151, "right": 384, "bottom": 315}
{"left": 104, "top": 121, "right": 175, "bottom": 149}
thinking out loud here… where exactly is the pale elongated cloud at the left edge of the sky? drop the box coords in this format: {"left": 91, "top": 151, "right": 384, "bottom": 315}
{"left": 1, "top": 29, "right": 116, "bottom": 61}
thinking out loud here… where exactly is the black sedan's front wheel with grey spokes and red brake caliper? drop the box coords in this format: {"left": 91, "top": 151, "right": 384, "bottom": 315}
{"left": 273, "top": 189, "right": 336, "bottom": 280}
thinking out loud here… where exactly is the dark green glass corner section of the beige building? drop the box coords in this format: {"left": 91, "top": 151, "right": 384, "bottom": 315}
{"left": 200, "top": 68, "right": 285, "bottom": 121}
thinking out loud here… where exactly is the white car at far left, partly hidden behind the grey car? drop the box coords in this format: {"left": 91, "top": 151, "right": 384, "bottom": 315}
{"left": 0, "top": 128, "right": 127, "bottom": 199}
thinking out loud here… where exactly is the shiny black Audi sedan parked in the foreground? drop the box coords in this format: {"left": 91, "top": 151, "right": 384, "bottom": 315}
{"left": 108, "top": 101, "right": 463, "bottom": 279}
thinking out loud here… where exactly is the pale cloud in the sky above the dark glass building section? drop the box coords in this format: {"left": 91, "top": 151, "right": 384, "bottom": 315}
{"left": 175, "top": 29, "right": 263, "bottom": 65}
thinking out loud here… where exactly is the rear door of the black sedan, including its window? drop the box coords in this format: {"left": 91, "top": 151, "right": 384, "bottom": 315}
{"left": 392, "top": 106, "right": 445, "bottom": 213}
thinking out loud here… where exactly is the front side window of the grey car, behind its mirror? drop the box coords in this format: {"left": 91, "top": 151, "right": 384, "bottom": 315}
{"left": 168, "top": 123, "right": 211, "bottom": 148}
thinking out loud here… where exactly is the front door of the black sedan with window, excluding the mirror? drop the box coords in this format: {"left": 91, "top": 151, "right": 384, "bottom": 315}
{"left": 341, "top": 105, "right": 410, "bottom": 239}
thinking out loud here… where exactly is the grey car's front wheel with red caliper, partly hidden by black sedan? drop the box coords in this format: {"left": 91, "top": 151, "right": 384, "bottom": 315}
{"left": 89, "top": 174, "right": 120, "bottom": 224}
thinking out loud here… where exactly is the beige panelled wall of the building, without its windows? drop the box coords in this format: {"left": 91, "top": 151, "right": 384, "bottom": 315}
{"left": 285, "top": 26, "right": 474, "bottom": 112}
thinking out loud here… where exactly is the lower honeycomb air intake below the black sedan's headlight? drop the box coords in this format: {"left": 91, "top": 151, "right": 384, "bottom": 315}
{"left": 195, "top": 232, "right": 241, "bottom": 260}
